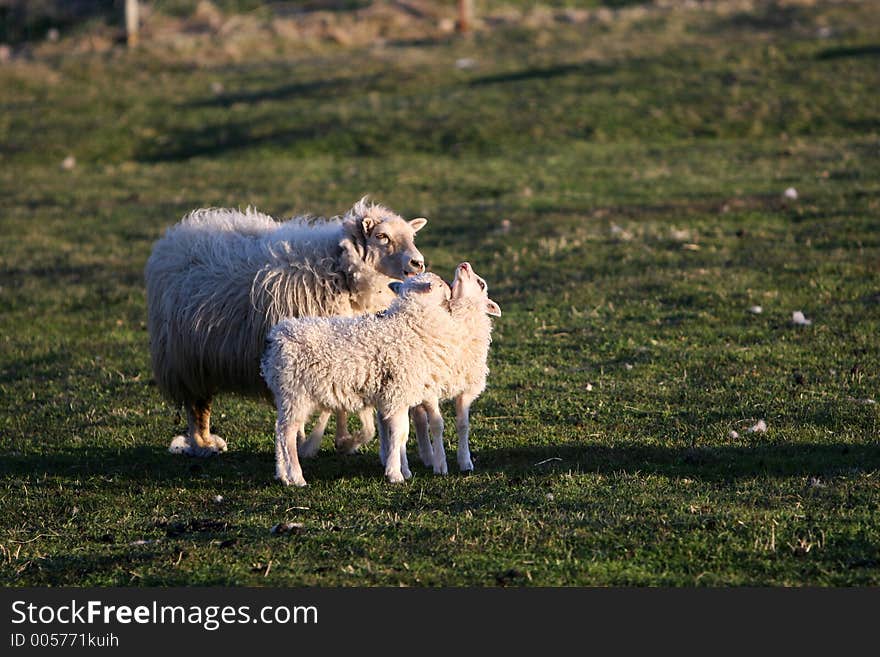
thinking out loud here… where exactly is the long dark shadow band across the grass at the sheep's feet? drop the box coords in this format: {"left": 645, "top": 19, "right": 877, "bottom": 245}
{"left": 0, "top": 443, "right": 880, "bottom": 488}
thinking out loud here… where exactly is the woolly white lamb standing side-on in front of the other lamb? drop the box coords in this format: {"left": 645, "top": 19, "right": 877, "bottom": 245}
{"left": 261, "top": 273, "right": 459, "bottom": 486}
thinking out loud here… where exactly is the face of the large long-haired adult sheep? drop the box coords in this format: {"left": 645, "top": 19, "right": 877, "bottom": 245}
{"left": 361, "top": 205, "right": 428, "bottom": 281}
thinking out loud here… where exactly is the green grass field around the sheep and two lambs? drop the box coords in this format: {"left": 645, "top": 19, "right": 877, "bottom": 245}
{"left": 0, "top": 1, "right": 880, "bottom": 586}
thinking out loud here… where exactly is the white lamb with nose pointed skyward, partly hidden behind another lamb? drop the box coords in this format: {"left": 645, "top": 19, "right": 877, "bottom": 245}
{"left": 379, "top": 262, "right": 501, "bottom": 474}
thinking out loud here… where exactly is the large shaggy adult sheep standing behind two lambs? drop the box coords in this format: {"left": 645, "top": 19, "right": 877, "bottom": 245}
{"left": 145, "top": 198, "right": 427, "bottom": 456}
